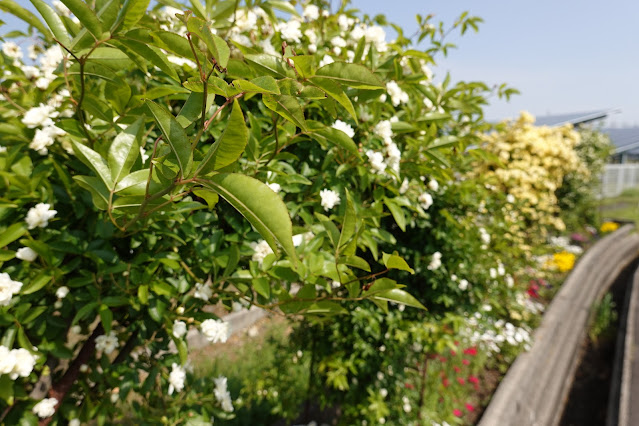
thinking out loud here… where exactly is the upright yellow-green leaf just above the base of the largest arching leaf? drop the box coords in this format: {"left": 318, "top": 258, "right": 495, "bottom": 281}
{"left": 195, "top": 99, "right": 249, "bottom": 175}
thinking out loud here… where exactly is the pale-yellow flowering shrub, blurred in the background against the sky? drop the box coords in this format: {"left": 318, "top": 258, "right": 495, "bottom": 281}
{"left": 473, "top": 112, "right": 589, "bottom": 238}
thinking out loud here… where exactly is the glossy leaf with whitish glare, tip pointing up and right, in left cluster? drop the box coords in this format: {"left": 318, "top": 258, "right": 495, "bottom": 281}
{"left": 107, "top": 116, "right": 144, "bottom": 184}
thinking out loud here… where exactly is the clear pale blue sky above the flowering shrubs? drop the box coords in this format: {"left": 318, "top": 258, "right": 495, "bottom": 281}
{"left": 5, "top": 0, "right": 639, "bottom": 126}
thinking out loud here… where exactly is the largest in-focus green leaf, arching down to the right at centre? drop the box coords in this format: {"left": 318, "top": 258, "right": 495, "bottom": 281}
{"left": 201, "top": 173, "right": 297, "bottom": 262}
